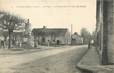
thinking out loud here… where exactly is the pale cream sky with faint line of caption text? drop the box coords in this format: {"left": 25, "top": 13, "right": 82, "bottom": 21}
{"left": 0, "top": 0, "right": 96, "bottom": 33}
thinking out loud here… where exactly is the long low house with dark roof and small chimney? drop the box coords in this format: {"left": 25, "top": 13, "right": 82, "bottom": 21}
{"left": 32, "top": 26, "right": 70, "bottom": 46}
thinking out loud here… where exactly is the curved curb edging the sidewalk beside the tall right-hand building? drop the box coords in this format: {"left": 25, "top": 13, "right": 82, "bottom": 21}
{"left": 76, "top": 48, "right": 114, "bottom": 73}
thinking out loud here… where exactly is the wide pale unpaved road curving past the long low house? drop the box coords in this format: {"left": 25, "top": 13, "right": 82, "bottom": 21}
{"left": 0, "top": 45, "right": 87, "bottom": 73}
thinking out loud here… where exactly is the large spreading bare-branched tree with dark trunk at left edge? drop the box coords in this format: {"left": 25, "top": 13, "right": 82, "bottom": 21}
{"left": 0, "top": 12, "right": 24, "bottom": 48}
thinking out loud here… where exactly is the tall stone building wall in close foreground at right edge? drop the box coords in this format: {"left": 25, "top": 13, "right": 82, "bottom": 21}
{"left": 96, "top": 0, "right": 114, "bottom": 65}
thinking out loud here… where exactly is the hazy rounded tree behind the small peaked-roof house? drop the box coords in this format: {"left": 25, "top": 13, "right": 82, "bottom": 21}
{"left": 81, "top": 28, "right": 91, "bottom": 44}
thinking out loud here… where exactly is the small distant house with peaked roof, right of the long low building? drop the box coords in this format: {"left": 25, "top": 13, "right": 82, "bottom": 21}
{"left": 71, "top": 32, "right": 83, "bottom": 45}
